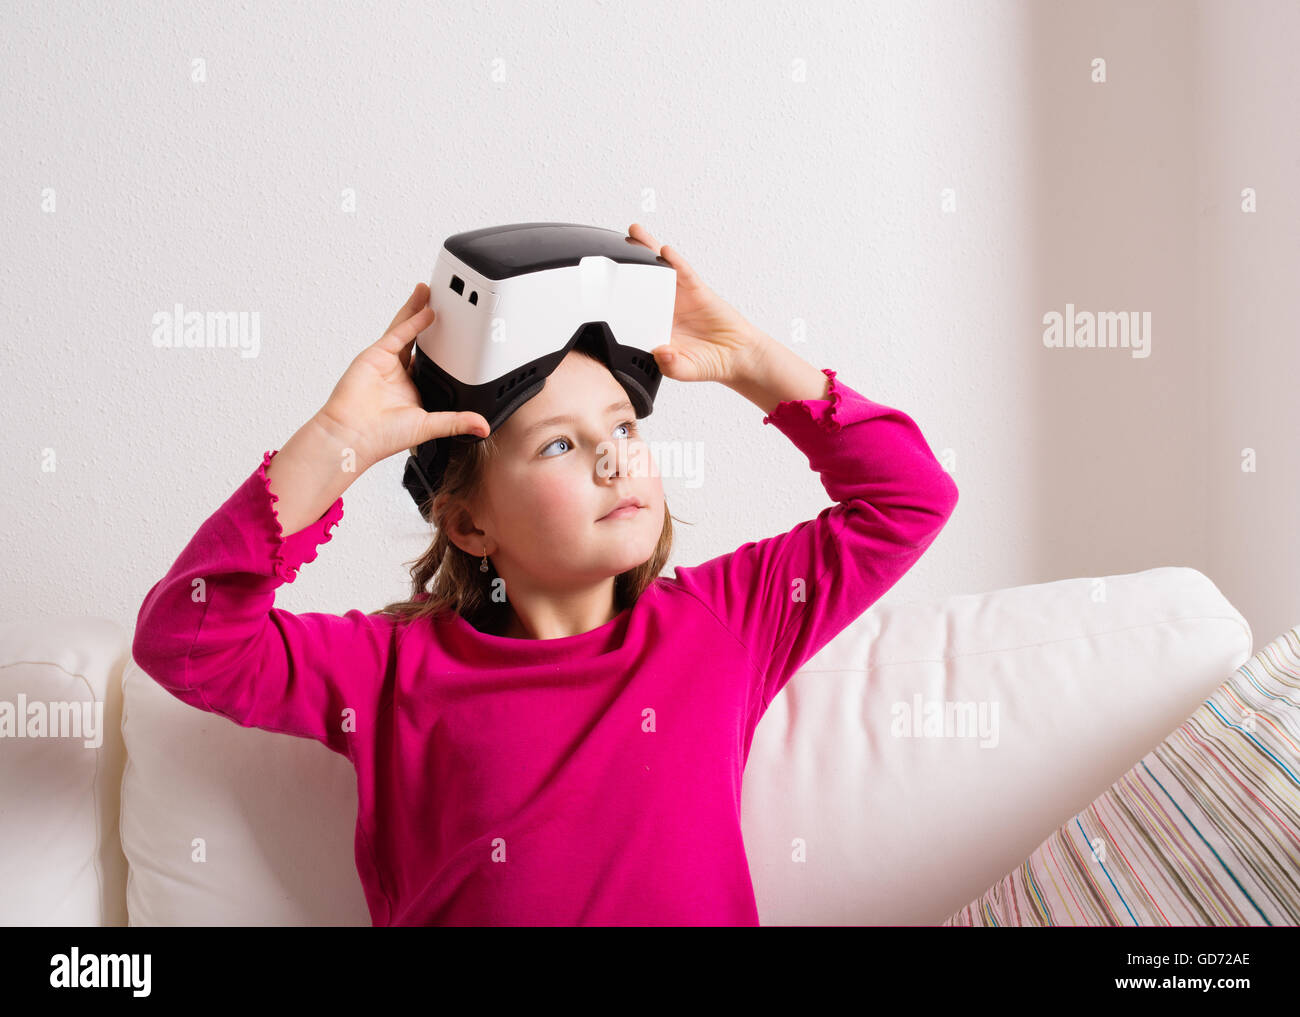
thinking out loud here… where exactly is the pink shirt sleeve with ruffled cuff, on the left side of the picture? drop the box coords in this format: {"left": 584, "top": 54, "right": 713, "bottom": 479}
{"left": 131, "top": 439, "right": 384, "bottom": 756}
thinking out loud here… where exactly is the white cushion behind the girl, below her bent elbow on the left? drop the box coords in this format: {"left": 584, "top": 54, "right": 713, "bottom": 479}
{"left": 122, "top": 659, "right": 371, "bottom": 926}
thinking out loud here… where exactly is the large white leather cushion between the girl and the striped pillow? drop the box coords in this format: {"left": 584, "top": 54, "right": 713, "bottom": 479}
{"left": 742, "top": 568, "right": 1252, "bottom": 925}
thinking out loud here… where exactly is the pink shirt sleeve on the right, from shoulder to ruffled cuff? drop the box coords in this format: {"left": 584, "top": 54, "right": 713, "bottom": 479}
{"left": 675, "top": 354, "right": 958, "bottom": 722}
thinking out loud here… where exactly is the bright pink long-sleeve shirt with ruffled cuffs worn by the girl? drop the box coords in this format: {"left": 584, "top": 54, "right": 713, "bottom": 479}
{"left": 133, "top": 369, "right": 957, "bottom": 926}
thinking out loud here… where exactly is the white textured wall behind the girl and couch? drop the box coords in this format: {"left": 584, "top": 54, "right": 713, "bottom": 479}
{"left": 0, "top": 0, "right": 1300, "bottom": 641}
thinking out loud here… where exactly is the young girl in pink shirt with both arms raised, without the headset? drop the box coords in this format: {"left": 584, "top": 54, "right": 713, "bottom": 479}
{"left": 133, "top": 225, "right": 957, "bottom": 926}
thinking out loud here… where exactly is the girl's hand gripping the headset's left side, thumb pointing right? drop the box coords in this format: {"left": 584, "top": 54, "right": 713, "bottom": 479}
{"left": 317, "top": 282, "right": 489, "bottom": 468}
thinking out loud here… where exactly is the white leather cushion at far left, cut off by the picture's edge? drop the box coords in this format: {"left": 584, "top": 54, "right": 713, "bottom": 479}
{"left": 0, "top": 616, "right": 130, "bottom": 926}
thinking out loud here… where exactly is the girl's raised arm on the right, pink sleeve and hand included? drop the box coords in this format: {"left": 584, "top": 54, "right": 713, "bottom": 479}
{"left": 618, "top": 222, "right": 957, "bottom": 723}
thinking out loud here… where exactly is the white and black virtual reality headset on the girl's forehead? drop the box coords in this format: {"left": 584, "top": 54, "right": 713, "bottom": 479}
{"left": 402, "top": 222, "right": 677, "bottom": 520}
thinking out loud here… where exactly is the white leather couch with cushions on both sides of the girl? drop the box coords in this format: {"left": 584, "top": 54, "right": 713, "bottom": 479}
{"left": 0, "top": 568, "right": 1252, "bottom": 926}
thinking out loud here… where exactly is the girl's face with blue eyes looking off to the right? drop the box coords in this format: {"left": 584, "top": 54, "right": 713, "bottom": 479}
{"left": 471, "top": 352, "right": 664, "bottom": 596}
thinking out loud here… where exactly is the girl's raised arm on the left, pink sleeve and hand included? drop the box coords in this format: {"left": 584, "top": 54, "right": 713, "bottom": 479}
{"left": 131, "top": 284, "right": 488, "bottom": 756}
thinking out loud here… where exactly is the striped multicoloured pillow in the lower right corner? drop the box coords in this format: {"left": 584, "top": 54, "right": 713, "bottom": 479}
{"left": 944, "top": 626, "right": 1300, "bottom": 926}
